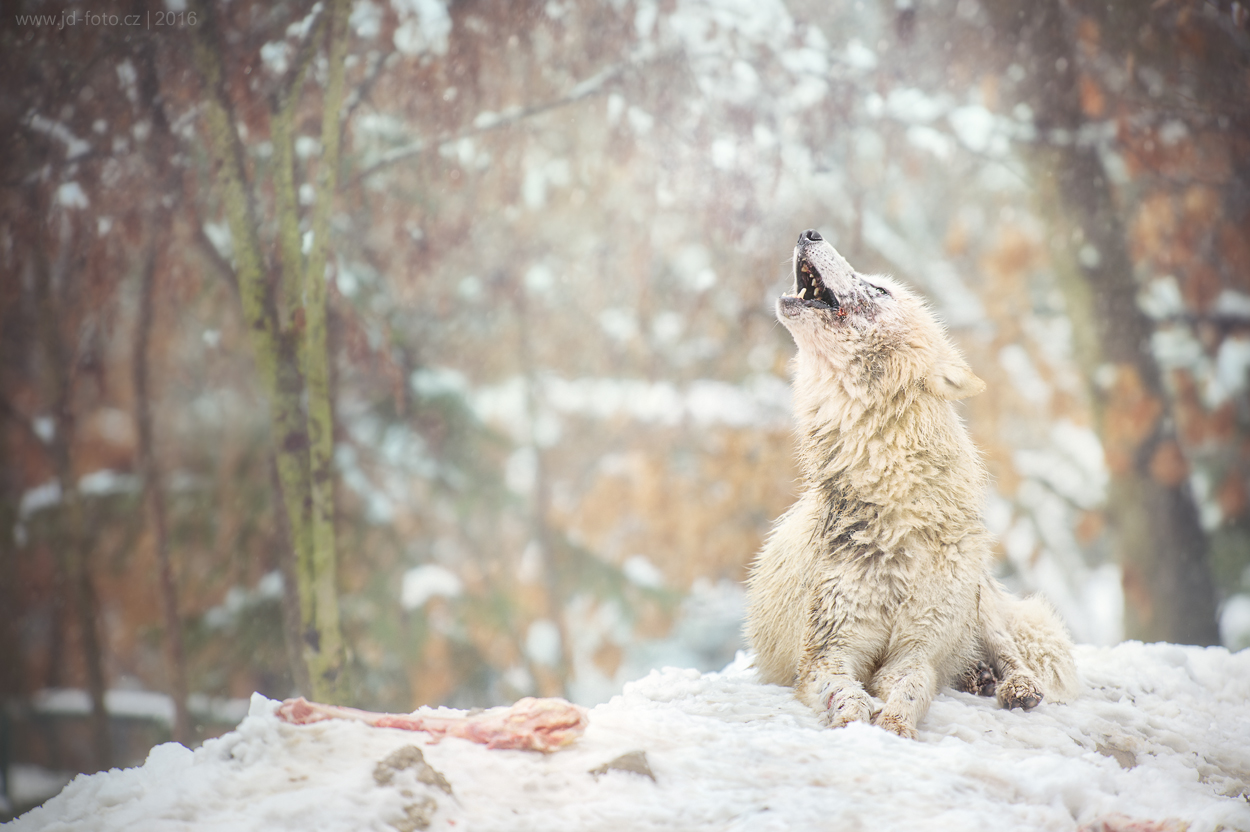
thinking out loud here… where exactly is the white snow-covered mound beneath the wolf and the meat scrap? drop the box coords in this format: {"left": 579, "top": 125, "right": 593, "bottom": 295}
{"left": 6, "top": 642, "right": 1250, "bottom": 832}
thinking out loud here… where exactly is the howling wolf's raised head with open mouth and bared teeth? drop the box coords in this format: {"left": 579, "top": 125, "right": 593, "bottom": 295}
{"left": 778, "top": 230, "right": 985, "bottom": 400}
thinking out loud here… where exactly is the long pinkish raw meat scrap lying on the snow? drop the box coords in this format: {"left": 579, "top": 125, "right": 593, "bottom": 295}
{"left": 278, "top": 696, "right": 589, "bottom": 752}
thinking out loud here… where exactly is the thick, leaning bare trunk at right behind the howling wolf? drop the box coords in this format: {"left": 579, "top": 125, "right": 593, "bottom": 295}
{"left": 986, "top": 0, "right": 1219, "bottom": 645}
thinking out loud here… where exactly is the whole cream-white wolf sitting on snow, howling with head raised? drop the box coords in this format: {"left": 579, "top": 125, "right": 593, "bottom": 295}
{"left": 746, "top": 231, "right": 1078, "bottom": 737}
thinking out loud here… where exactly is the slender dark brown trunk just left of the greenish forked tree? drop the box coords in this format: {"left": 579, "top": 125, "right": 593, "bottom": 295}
{"left": 134, "top": 238, "right": 191, "bottom": 745}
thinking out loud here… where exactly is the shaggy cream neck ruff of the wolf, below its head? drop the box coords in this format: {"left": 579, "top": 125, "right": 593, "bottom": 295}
{"left": 794, "top": 350, "right": 985, "bottom": 551}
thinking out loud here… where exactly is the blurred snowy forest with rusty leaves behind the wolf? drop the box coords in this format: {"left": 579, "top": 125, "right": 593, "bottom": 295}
{"left": 0, "top": 0, "right": 1250, "bottom": 813}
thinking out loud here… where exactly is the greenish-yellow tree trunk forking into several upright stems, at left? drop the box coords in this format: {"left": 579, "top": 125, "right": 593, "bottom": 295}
{"left": 193, "top": 0, "right": 349, "bottom": 701}
